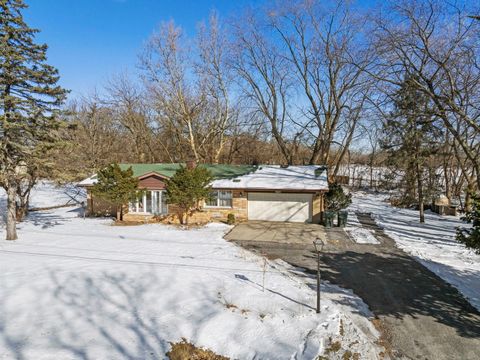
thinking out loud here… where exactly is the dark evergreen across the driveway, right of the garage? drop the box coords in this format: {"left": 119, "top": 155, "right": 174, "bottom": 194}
{"left": 381, "top": 75, "right": 441, "bottom": 223}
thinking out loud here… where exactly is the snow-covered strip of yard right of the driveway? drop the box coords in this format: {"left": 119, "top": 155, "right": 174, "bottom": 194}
{"left": 349, "top": 192, "right": 480, "bottom": 309}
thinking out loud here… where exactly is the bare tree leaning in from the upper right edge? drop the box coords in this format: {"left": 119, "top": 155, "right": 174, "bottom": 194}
{"left": 371, "top": 0, "right": 480, "bottom": 193}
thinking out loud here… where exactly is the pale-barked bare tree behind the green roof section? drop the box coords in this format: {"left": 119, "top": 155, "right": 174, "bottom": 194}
{"left": 141, "top": 15, "right": 235, "bottom": 163}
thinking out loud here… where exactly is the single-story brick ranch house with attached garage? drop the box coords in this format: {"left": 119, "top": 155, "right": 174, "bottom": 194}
{"left": 78, "top": 164, "right": 328, "bottom": 223}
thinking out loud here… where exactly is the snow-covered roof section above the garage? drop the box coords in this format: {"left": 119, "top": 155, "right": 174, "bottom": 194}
{"left": 212, "top": 165, "right": 328, "bottom": 190}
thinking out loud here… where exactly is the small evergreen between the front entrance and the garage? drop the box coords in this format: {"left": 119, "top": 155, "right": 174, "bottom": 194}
{"left": 166, "top": 166, "right": 212, "bottom": 224}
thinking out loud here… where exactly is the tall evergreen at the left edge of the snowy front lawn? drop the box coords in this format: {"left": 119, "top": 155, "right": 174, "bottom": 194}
{"left": 0, "top": 0, "right": 66, "bottom": 240}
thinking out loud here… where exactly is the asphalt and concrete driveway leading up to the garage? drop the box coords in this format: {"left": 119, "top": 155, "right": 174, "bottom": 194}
{"left": 229, "top": 218, "right": 480, "bottom": 360}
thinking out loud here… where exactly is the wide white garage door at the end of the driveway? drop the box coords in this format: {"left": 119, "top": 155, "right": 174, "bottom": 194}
{"left": 248, "top": 192, "right": 312, "bottom": 222}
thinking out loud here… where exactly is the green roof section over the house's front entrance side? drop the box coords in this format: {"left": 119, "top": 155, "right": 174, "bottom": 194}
{"left": 119, "top": 163, "right": 257, "bottom": 180}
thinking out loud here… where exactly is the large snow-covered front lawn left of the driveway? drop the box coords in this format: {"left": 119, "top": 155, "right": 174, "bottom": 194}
{"left": 0, "top": 184, "right": 381, "bottom": 360}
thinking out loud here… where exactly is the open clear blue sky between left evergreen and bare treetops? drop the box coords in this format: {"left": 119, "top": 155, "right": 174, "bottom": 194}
{"left": 24, "top": 0, "right": 258, "bottom": 97}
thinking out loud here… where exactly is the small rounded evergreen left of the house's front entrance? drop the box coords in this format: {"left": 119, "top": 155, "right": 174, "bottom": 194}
{"left": 92, "top": 164, "right": 141, "bottom": 221}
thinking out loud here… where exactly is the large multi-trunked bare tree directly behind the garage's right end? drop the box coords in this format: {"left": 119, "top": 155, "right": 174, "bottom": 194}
{"left": 270, "top": 1, "right": 368, "bottom": 175}
